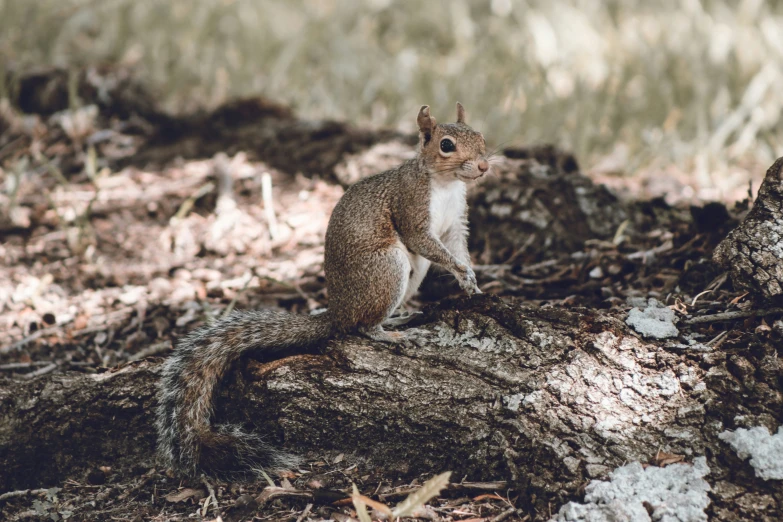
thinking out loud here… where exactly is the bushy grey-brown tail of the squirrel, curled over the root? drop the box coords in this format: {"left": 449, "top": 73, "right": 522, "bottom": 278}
{"left": 156, "top": 310, "right": 336, "bottom": 476}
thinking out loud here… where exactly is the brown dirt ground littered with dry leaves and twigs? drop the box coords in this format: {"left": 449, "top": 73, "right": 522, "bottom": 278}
{"left": 0, "top": 67, "right": 780, "bottom": 522}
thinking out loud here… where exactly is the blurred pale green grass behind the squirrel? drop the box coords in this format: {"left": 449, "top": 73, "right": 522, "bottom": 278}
{"left": 0, "top": 0, "right": 783, "bottom": 201}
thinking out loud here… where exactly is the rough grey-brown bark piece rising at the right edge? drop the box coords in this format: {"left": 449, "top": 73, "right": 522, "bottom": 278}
{"left": 713, "top": 157, "right": 783, "bottom": 299}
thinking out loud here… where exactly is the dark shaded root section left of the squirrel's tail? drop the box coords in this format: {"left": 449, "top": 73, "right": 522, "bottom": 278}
{"left": 0, "top": 362, "right": 158, "bottom": 491}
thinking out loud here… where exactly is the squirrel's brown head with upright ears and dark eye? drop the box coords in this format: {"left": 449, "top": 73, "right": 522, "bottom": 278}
{"left": 416, "top": 102, "right": 489, "bottom": 181}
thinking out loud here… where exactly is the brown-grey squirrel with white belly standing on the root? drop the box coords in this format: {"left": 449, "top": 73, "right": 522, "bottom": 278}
{"left": 156, "top": 103, "right": 490, "bottom": 476}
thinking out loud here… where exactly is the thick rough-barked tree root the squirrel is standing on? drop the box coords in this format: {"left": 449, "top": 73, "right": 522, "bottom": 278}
{"left": 0, "top": 295, "right": 783, "bottom": 520}
